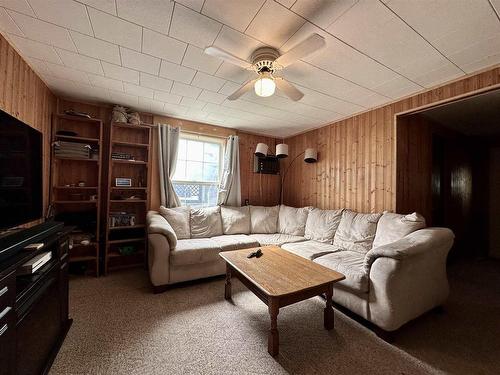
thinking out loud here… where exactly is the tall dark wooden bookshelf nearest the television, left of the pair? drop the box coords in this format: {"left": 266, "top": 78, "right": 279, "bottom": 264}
{"left": 50, "top": 114, "right": 103, "bottom": 276}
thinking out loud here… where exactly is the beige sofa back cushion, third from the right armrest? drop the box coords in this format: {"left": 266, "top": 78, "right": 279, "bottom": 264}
{"left": 304, "top": 208, "right": 342, "bottom": 244}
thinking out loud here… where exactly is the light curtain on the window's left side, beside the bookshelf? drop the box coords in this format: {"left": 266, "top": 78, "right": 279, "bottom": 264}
{"left": 158, "top": 124, "right": 181, "bottom": 207}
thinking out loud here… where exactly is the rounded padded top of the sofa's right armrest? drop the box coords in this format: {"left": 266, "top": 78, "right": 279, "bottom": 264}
{"left": 364, "top": 228, "right": 455, "bottom": 270}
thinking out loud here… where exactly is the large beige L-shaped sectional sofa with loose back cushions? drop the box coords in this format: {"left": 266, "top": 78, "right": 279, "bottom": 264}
{"left": 148, "top": 205, "right": 454, "bottom": 331}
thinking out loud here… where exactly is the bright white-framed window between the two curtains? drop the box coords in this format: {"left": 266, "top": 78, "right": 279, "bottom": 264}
{"left": 173, "top": 134, "right": 224, "bottom": 207}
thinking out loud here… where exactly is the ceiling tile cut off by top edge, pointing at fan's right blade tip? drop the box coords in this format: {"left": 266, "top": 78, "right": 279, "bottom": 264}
{"left": 291, "top": 0, "right": 358, "bottom": 29}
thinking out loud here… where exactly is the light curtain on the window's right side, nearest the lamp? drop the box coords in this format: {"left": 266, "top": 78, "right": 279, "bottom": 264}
{"left": 217, "top": 135, "right": 241, "bottom": 206}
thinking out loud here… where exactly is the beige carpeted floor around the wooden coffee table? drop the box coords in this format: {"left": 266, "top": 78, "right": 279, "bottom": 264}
{"left": 51, "top": 261, "right": 500, "bottom": 375}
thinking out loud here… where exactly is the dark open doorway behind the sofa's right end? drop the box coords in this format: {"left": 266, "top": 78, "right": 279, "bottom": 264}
{"left": 396, "top": 90, "right": 500, "bottom": 258}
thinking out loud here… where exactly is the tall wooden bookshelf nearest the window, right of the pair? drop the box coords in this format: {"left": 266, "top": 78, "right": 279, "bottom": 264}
{"left": 104, "top": 123, "right": 153, "bottom": 274}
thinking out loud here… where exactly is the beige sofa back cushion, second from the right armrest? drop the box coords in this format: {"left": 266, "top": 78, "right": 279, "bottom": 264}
{"left": 333, "top": 210, "right": 382, "bottom": 254}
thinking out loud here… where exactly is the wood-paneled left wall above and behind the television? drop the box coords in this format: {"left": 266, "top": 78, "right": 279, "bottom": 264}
{"left": 0, "top": 35, "right": 56, "bottom": 225}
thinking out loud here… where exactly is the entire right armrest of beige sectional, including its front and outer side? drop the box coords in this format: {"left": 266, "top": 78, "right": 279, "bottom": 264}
{"left": 365, "top": 228, "right": 454, "bottom": 331}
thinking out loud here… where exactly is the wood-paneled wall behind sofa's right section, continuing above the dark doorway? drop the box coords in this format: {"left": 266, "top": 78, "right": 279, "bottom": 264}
{"left": 284, "top": 67, "right": 500, "bottom": 212}
